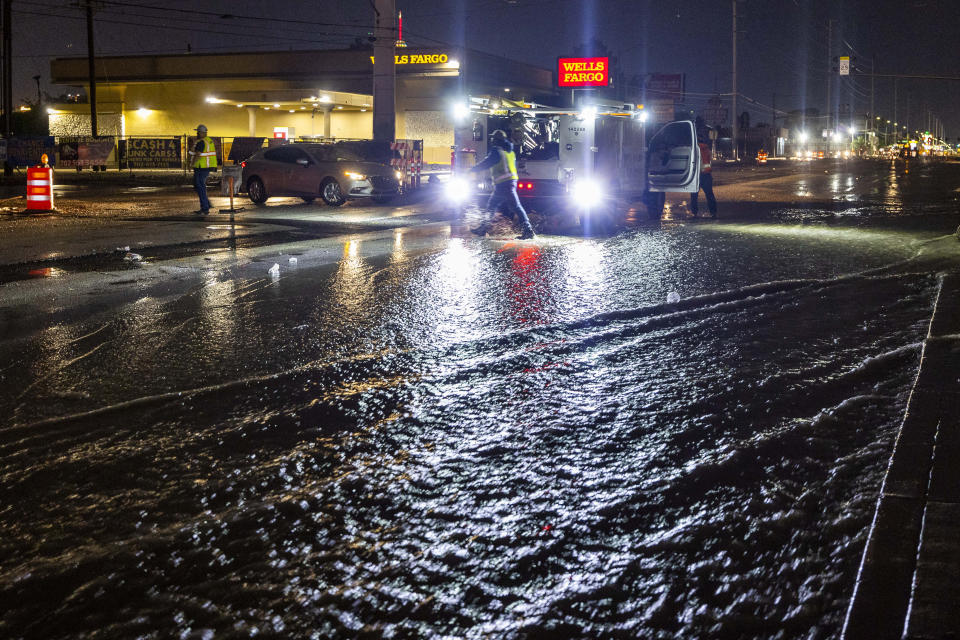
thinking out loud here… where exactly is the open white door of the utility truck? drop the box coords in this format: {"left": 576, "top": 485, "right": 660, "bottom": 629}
{"left": 647, "top": 120, "right": 700, "bottom": 193}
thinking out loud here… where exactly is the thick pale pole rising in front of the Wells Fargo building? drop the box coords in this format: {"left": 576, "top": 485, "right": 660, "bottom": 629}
{"left": 373, "top": 0, "right": 397, "bottom": 142}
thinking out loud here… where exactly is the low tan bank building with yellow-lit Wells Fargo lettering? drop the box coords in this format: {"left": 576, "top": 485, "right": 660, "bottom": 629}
{"left": 50, "top": 49, "right": 555, "bottom": 163}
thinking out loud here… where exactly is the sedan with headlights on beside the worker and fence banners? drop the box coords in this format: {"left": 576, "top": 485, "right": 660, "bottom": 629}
{"left": 241, "top": 143, "right": 400, "bottom": 207}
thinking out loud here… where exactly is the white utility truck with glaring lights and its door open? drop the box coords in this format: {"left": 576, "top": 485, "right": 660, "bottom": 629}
{"left": 450, "top": 98, "right": 700, "bottom": 228}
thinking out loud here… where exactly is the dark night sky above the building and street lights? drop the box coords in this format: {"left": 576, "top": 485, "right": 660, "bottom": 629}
{"left": 13, "top": 0, "right": 960, "bottom": 137}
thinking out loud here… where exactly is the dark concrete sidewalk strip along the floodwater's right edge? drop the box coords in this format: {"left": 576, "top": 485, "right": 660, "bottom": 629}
{"left": 843, "top": 274, "right": 960, "bottom": 640}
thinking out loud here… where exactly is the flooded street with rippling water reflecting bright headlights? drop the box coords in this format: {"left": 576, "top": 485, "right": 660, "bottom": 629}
{"left": 0, "top": 159, "right": 958, "bottom": 638}
